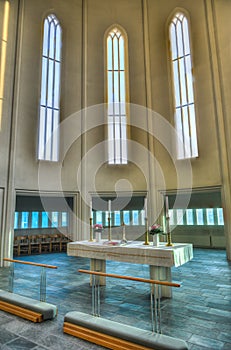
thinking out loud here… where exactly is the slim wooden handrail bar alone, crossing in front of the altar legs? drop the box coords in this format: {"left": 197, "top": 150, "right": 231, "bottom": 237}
{"left": 78, "top": 269, "right": 180, "bottom": 288}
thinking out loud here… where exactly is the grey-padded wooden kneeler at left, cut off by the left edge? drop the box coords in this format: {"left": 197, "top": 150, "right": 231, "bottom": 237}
{"left": 0, "top": 289, "right": 57, "bottom": 322}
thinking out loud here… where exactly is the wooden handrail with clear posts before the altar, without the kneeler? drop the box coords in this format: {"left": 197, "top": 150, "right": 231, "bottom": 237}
{"left": 78, "top": 269, "right": 181, "bottom": 333}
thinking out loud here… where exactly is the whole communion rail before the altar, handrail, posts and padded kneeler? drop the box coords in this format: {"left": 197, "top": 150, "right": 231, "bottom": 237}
{"left": 63, "top": 269, "right": 188, "bottom": 350}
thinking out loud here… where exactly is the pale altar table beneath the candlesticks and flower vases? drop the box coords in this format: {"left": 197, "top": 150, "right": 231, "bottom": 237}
{"left": 67, "top": 240, "right": 193, "bottom": 298}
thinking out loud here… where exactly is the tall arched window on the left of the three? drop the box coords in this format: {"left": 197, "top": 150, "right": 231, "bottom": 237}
{"left": 38, "top": 14, "right": 62, "bottom": 161}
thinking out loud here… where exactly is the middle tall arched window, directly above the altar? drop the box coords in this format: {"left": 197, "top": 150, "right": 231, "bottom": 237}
{"left": 106, "top": 26, "right": 128, "bottom": 164}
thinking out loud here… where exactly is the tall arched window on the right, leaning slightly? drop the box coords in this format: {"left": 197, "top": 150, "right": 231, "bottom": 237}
{"left": 169, "top": 12, "right": 198, "bottom": 159}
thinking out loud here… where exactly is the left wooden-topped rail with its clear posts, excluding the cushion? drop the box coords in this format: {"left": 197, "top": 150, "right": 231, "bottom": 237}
{"left": 3, "top": 258, "right": 57, "bottom": 301}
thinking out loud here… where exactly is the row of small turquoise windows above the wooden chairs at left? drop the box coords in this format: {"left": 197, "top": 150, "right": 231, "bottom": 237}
{"left": 14, "top": 211, "right": 69, "bottom": 230}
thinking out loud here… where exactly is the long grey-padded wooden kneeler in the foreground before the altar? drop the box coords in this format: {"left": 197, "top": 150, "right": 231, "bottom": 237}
{"left": 63, "top": 311, "right": 188, "bottom": 350}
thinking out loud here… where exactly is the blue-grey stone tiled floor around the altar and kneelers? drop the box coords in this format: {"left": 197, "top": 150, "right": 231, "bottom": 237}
{"left": 0, "top": 249, "right": 231, "bottom": 350}
